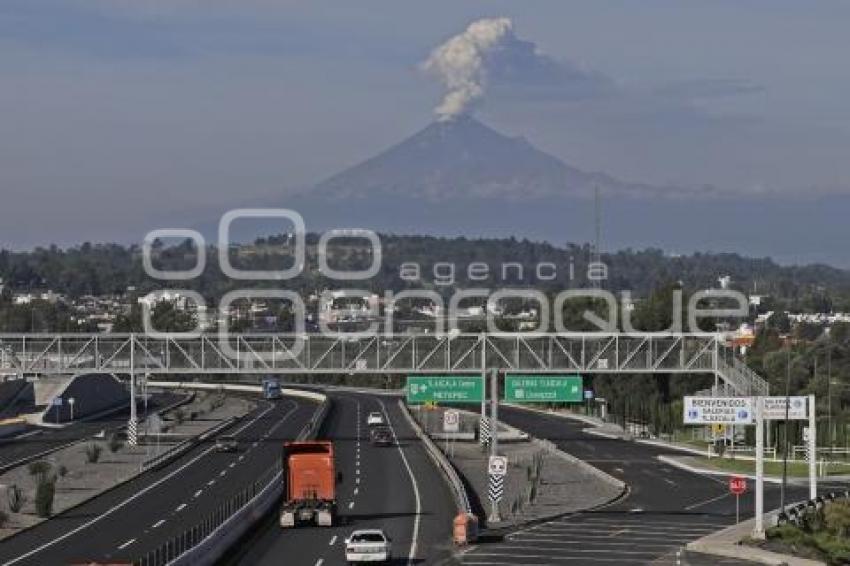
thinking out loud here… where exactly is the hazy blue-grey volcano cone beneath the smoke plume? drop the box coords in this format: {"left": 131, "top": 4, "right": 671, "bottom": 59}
{"left": 311, "top": 116, "right": 664, "bottom": 202}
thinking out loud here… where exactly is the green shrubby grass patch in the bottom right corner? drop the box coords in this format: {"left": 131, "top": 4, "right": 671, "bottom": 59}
{"left": 748, "top": 501, "right": 850, "bottom": 564}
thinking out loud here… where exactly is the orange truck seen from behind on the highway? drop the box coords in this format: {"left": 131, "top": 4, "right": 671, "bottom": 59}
{"left": 280, "top": 441, "right": 341, "bottom": 528}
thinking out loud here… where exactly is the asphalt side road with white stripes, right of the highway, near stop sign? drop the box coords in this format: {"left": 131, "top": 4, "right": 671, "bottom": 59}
{"left": 454, "top": 407, "right": 844, "bottom": 565}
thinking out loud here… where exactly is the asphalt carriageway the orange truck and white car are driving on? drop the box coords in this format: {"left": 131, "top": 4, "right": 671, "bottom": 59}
{"left": 225, "top": 393, "right": 457, "bottom": 566}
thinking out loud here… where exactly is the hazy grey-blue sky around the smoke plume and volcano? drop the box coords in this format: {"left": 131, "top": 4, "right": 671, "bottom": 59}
{"left": 0, "top": 0, "right": 850, "bottom": 246}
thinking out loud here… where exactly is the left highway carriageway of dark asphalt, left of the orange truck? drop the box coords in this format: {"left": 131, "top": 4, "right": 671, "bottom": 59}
{"left": 0, "top": 398, "right": 317, "bottom": 566}
